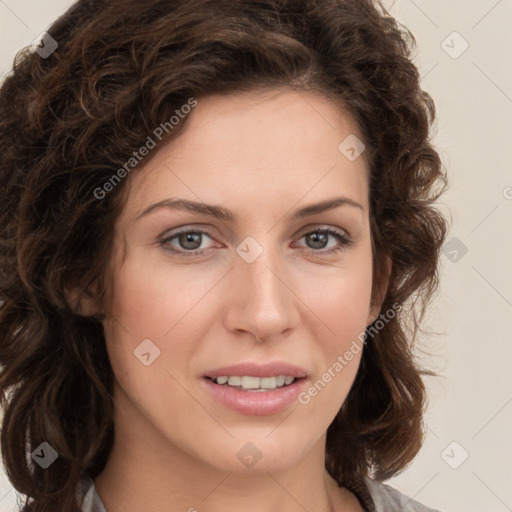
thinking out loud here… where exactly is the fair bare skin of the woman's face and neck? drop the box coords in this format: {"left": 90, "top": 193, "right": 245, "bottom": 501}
{"left": 82, "top": 88, "right": 388, "bottom": 512}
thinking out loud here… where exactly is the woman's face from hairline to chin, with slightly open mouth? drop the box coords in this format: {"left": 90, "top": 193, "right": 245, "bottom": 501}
{"left": 100, "top": 89, "right": 382, "bottom": 471}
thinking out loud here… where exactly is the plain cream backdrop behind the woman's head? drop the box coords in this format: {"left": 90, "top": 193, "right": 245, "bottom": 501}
{"left": 0, "top": 0, "right": 512, "bottom": 512}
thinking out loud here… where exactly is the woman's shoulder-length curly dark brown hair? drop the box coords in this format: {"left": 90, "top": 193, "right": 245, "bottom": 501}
{"left": 0, "top": 0, "right": 447, "bottom": 512}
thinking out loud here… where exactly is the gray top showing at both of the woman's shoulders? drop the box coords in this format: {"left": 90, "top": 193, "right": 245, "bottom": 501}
{"left": 72, "top": 476, "right": 439, "bottom": 512}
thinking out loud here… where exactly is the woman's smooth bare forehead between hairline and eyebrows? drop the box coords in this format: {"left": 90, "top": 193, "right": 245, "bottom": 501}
{"left": 121, "top": 88, "right": 368, "bottom": 222}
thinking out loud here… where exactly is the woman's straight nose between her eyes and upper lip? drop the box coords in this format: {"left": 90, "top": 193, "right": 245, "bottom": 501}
{"left": 225, "top": 239, "right": 300, "bottom": 341}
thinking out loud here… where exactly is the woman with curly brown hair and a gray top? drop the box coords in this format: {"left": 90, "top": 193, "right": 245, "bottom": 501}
{"left": 0, "top": 0, "right": 446, "bottom": 512}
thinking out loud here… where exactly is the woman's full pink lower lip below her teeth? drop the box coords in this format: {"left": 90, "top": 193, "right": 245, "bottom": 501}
{"left": 202, "top": 377, "right": 307, "bottom": 416}
